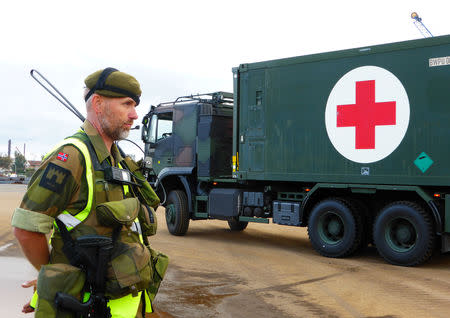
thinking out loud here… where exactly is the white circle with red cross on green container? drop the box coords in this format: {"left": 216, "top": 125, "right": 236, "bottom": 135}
{"left": 325, "top": 66, "right": 410, "bottom": 163}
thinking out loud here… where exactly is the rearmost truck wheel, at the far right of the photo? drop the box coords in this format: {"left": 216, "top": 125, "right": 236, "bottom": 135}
{"left": 373, "top": 201, "right": 435, "bottom": 266}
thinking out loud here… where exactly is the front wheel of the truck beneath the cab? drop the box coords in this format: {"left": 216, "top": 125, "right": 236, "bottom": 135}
{"left": 166, "top": 190, "right": 189, "bottom": 236}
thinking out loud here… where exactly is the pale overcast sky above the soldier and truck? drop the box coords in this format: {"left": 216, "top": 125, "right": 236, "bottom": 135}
{"left": 0, "top": 0, "right": 450, "bottom": 160}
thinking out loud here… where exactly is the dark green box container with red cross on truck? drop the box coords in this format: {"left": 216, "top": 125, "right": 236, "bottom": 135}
{"left": 233, "top": 36, "right": 450, "bottom": 186}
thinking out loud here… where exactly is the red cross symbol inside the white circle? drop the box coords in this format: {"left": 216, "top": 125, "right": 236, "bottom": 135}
{"left": 337, "top": 80, "right": 396, "bottom": 149}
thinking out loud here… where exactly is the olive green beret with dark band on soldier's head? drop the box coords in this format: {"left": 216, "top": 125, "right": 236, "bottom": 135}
{"left": 84, "top": 67, "right": 142, "bottom": 104}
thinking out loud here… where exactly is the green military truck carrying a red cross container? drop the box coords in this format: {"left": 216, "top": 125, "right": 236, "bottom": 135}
{"left": 142, "top": 36, "right": 450, "bottom": 266}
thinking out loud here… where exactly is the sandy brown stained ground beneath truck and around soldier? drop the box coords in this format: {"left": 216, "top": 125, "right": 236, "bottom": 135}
{"left": 0, "top": 185, "right": 450, "bottom": 318}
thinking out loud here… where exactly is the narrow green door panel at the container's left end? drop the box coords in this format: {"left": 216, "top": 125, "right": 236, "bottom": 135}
{"left": 239, "top": 71, "right": 266, "bottom": 173}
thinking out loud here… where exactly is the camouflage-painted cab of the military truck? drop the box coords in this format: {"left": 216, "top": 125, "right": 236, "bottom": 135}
{"left": 142, "top": 92, "right": 233, "bottom": 235}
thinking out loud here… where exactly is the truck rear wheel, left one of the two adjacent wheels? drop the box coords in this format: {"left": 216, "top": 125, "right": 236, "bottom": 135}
{"left": 308, "top": 199, "right": 363, "bottom": 257}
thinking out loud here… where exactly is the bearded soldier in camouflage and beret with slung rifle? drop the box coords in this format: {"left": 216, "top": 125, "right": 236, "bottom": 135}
{"left": 12, "top": 68, "right": 164, "bottom": 317}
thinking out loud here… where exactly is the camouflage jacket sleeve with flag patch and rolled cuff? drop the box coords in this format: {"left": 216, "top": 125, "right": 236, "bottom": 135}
{"left": 11, "top": 145, "right": 87, "bottom": 233}
